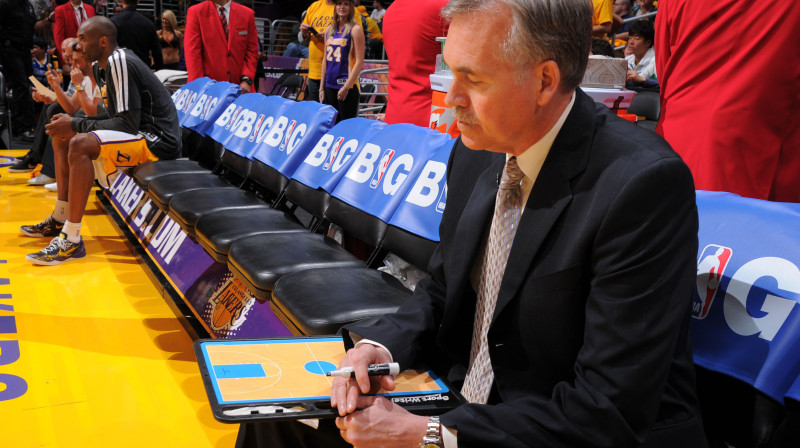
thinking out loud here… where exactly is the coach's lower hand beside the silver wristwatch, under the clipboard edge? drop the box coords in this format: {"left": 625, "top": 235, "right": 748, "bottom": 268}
{"left": 336, "top": 397, "right": 428, "bottom": 448}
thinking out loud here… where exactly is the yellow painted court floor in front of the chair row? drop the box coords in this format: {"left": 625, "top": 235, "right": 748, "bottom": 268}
{"left": 0, "top": 151, "right": 237, "bottom": 448}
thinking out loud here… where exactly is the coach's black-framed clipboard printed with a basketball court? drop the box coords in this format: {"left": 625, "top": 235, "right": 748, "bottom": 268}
{"left": 194, "top": 336, "right": 466, "bottom": 423}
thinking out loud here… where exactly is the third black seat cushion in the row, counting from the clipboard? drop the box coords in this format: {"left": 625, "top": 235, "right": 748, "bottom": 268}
{"left": 194, "top": 208, "right": 307, "bottom": 263}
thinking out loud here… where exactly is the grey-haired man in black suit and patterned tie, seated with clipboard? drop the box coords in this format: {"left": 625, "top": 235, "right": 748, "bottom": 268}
{"left": 322, "top": 0, "right": 706, "bottom": 448}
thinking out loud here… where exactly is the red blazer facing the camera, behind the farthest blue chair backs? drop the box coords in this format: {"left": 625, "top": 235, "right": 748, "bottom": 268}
{"left": 183, "top": 0, "right": 258, "bottom": 84}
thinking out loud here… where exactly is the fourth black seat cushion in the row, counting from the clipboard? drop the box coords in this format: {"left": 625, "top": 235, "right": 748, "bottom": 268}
{"left": 169, "top": 188, "right": 268, "bottom": 234}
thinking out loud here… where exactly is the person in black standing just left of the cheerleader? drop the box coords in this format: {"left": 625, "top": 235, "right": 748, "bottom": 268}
{"left": 111, "top": 0, "right": 164, "bottom": 70}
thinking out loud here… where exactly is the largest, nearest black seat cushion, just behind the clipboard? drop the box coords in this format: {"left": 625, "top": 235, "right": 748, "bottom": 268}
{"left": 270, "top": 268, "right": 412, "bottom": 335}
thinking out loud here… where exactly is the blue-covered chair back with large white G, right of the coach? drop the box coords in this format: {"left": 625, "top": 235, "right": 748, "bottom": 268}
{"left": 692, "top": 191, "right": 800, "bottom": 446}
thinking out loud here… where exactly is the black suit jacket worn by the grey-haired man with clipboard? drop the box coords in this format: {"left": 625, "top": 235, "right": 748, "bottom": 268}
{"left": 345, "top": 91, "right": 705, "bottom": 448}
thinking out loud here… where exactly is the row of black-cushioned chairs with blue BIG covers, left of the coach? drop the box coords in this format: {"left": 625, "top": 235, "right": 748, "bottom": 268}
{"left": 133, "top": 79, "right": 454, "bottom": 334}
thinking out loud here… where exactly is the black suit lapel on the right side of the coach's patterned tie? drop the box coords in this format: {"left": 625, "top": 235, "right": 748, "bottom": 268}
{"left": 492, "top": 90, "right": 595, "bottom": 322}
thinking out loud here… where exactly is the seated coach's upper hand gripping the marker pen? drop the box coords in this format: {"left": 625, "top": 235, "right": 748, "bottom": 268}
{"left": 331, "top": 344, "right": 394, "bottom": 415}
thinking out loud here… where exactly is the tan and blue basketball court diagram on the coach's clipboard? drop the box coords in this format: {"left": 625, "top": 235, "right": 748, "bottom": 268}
{"left": 200, "top": 338, "right": 448, "bottom": 405}
